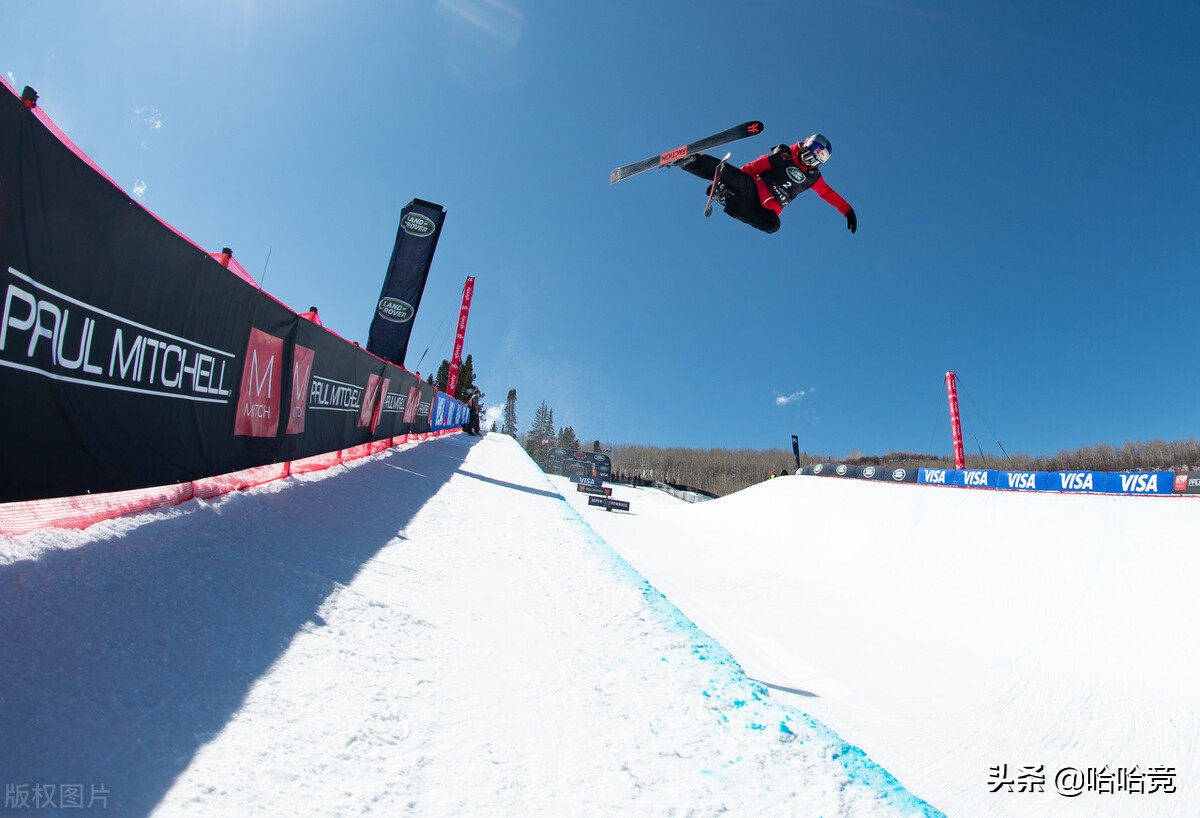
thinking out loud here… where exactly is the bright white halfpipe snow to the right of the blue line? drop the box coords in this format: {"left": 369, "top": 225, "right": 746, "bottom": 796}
{"left": 553, "top": 467, "right": 1200, "bottom": 817}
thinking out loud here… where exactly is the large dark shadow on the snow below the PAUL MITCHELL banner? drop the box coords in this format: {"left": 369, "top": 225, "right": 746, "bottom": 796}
{"left": 0, "top": 437, "right": 479, "bottom": 816}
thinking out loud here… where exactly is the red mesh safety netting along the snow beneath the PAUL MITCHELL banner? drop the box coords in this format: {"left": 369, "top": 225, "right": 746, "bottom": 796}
{"left": 0, "top": 429, "right": 460, "bottom": 535}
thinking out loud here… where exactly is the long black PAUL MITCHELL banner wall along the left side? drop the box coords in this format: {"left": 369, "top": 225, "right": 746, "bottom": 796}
{"left": 0, "top": 86, "right": 466, "bottom": 503}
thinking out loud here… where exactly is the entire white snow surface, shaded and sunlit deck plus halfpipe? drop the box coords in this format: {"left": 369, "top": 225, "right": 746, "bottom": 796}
{"left": 0, "top": 434, "right": 1200, "bottom": 817}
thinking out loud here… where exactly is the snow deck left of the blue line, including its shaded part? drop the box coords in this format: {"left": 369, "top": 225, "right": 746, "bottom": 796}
{"left": 0, "top": 435, "right": 938, "bottom": 818}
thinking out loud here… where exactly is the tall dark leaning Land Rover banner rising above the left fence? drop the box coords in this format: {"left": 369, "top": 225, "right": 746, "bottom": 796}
{"left": 367, "top": 199, "right": 446, "bottom": 366}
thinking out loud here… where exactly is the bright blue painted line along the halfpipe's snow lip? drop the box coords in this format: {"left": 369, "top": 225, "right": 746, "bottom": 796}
{"left": 546, "top": 465, "right": 946, "bottom": 818}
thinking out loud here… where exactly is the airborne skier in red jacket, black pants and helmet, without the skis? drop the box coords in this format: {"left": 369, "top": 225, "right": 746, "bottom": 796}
{"left": 672, "top": 133, "right": 858, "bottom": 233}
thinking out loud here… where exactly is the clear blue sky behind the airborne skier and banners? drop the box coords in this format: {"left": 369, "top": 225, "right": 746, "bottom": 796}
{"left": 0, "top": 0, "right": 1200, "bottom": 456}
